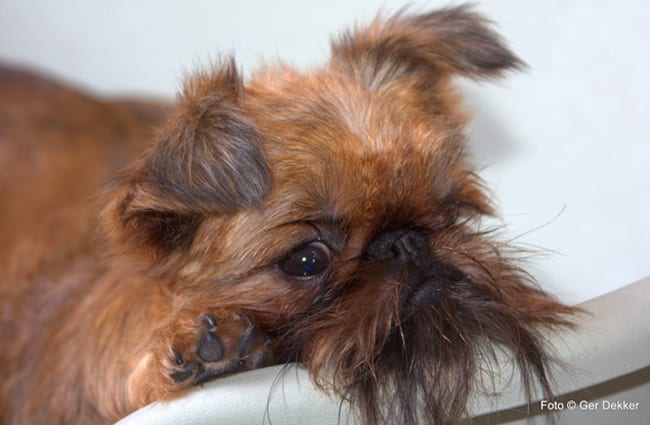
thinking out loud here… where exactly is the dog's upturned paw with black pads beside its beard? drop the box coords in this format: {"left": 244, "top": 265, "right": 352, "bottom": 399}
{"left": 167, "top": 314, "right": 273, "bottom": 386}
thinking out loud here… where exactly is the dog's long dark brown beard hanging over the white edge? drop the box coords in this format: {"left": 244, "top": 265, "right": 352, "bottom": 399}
{"left": 270, "top": 230, "right": 570, "bottom": 425}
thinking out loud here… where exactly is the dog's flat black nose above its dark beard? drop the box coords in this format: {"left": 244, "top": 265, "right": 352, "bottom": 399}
{"left": 367, "top": 229, "right": 429, "bottom": 267}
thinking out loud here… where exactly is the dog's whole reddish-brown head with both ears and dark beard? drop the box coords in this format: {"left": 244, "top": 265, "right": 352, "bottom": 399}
{"left": 104, "top": 8, "right": 570, "bottom": 424}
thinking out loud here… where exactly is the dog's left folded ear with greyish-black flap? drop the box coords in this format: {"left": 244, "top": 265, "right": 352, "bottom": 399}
{"left": 102, "top": 61, "right": 270, "bottom": 259}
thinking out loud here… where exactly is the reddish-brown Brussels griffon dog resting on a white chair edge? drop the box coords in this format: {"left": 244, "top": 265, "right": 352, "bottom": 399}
{"left": 0, "top": 7, "right": 572, "bottom": 424}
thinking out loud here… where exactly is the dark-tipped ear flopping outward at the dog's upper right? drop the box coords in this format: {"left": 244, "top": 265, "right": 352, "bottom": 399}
{"left": 332, "top": 6, "right": 523, "bottom": 87}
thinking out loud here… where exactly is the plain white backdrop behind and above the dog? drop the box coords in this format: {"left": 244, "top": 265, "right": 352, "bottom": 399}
{"left": 0, "top": 0, "right": 650, "bottom": 302}
